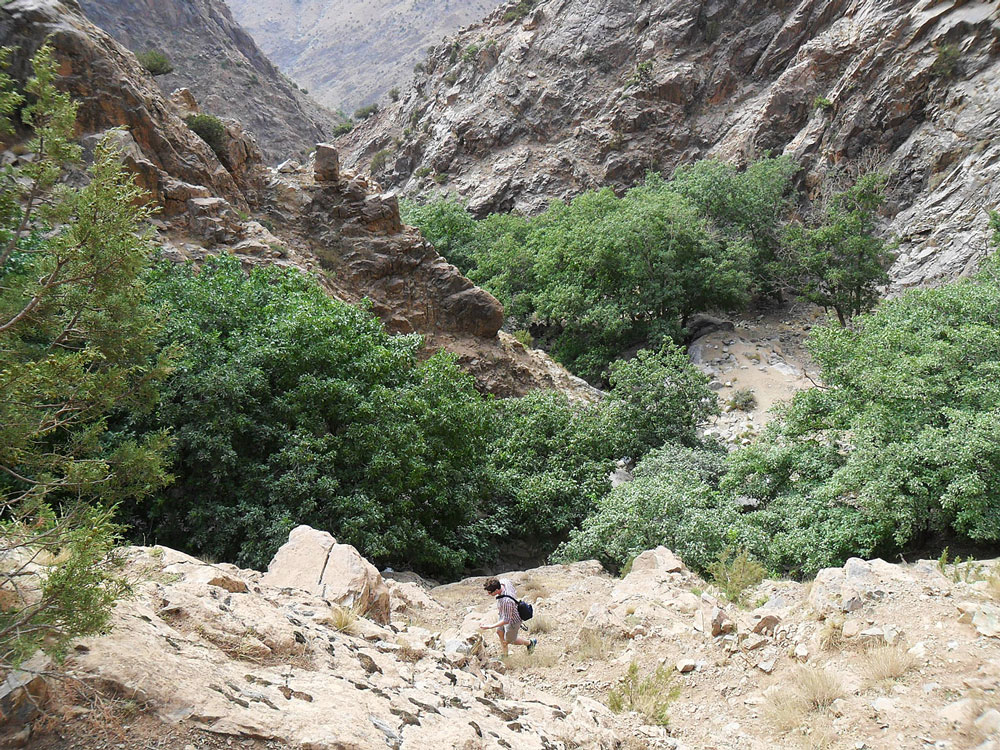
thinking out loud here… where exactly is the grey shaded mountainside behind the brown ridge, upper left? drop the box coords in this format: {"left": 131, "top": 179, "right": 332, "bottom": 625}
{"left": 80, "top": 0, "right": 336, "bottom": 163}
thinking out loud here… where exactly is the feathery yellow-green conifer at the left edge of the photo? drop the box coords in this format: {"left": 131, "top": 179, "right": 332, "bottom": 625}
{"left": 0, "top": 47, "right": 167, "bottom": 669}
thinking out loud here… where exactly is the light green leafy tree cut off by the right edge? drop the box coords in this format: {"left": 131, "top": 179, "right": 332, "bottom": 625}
{"left": 723, "top": 251, "right": 1000, "bottom": 574}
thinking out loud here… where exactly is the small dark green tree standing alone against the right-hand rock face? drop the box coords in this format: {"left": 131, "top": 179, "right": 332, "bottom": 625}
{"left": 792, "top": 173, "right": 894, "bottom": 325}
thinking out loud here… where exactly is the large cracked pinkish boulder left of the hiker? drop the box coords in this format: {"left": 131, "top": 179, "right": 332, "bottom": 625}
{"left": 260, "top": 526, "right": 390, "bottom": 625}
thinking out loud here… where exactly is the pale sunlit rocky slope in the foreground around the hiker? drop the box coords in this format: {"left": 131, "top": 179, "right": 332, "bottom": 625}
{"left": 7, "top": 527, "right": 1000, "bottom": 750}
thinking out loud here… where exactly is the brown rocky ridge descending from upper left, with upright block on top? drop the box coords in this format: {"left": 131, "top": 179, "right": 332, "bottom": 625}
{"left": 0, "top": 0, "right": 593, "bottom": 398}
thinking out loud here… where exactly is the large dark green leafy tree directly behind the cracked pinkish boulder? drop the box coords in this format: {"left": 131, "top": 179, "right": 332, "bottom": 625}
{"left": 122, "top": 258, "right": 493, "bottom": 573}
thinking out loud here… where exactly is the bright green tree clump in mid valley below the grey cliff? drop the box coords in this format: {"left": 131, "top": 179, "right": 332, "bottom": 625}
{"left": 408, "top": 168, "right": 780, "bottom": 381}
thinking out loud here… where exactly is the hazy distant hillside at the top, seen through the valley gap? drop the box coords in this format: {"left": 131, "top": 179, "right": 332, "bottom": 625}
{"left": 227, "top": 0, "right": 497, "bottom": 114}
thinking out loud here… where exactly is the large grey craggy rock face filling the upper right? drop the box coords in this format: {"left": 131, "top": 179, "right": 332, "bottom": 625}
{"left": 340, "top": 0, "right": 1000, "bottom": 286}
